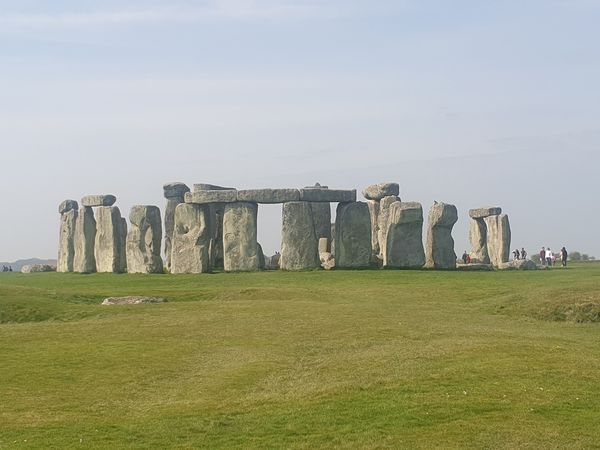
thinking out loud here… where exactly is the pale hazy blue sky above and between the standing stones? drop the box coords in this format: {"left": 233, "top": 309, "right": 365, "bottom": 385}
{"left": 0, "top": 0, "right": 600, "bottom": 261}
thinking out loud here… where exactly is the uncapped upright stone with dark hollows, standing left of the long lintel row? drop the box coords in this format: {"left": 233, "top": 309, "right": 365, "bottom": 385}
{"left": 127, "top": 205, "right": 163, "bottom": 273}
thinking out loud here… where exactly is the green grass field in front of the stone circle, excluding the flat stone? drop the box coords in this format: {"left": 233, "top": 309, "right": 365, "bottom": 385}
{"left": 0, "top": 264, "right": 600, "bottom": 449}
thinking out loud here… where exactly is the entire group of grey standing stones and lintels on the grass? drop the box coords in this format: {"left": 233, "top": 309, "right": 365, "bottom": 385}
{"left": 57, "top": 182, "right": 520, "bottom": 274}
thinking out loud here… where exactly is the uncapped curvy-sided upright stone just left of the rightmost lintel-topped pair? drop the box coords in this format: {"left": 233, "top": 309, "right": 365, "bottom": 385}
{"left": 425, "top": 202, "right": 458, "bottom": 269}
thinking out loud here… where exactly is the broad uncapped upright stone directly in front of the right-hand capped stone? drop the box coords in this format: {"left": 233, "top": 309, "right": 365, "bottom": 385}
{"left": 382, "top": 197, "right": 425, "bottom": 269}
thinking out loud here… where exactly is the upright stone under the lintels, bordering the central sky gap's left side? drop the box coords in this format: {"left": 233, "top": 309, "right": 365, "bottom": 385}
{"left": 223, "top": 203, "right": 260, "bottom": 272}
